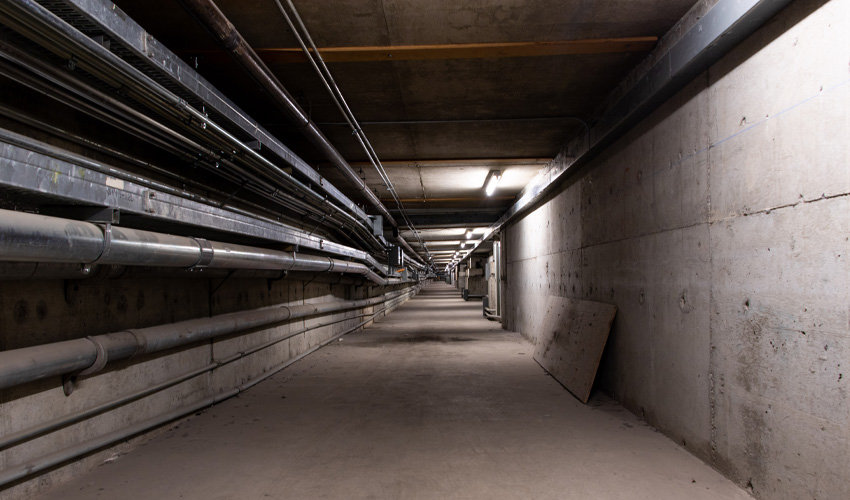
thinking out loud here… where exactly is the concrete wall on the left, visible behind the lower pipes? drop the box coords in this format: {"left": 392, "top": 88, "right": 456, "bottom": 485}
{"left": 0, "top": 277, "right": 412, "bottom": 500}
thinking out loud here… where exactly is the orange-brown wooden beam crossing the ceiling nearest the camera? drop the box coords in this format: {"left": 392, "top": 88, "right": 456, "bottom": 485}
{"left": 186, "top": 36, "right": 658, "bottom": 64}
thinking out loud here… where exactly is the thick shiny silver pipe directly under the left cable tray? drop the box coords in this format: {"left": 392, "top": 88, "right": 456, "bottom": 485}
{"left": 0, "top": 210, "right": 388, "bottom": 285}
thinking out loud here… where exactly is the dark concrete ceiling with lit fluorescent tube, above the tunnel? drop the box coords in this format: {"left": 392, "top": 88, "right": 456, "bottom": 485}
{"left": 116, "top": 0, "right": 694, "bottom": 262}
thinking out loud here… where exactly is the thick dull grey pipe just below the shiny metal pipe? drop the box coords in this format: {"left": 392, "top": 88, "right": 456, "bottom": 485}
{"left": 0, "top": 290, "right": 414, "bottom": 389}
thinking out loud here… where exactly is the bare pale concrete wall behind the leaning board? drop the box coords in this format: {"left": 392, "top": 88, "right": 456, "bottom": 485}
{"left": 503, "top": 0, "right": 850, "bottom": 499}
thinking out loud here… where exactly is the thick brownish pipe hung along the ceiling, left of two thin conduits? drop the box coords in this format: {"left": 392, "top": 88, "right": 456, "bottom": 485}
{"left": 180, "top": 0, "right": 398, "bottom": 227}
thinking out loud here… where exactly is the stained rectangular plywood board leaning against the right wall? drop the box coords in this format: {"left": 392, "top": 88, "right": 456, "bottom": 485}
{"left": 534, "top": 296, "right": 617, "bottom": 403}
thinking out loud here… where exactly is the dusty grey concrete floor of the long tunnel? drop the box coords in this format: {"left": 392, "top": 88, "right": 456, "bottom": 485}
{"left": 36, "top": 283, "right": 750, "bottom": 500}
